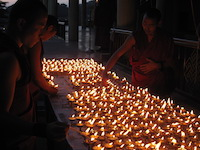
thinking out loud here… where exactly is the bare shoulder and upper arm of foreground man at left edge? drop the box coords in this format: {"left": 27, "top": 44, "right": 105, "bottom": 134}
{"left": 0, "top": 53, "right": 20, "bottom": 112}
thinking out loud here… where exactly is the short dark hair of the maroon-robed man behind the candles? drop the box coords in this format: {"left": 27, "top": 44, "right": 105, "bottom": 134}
{"left": 144, "top": 8, "right": 161, "bottom": 23}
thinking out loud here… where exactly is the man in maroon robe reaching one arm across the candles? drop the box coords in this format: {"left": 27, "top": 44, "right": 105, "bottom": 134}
{"left": 103, "top": 8, "right": 175, "bottom": 96}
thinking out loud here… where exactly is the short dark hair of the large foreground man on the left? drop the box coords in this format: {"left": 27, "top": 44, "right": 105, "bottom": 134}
{"left": 8, "top": 0, "right": 47, "bottom": 28}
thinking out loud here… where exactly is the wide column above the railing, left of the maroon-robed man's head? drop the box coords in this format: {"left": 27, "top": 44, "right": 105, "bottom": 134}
{"left": 117, "top": 0, "right": 136, "bottom": 30}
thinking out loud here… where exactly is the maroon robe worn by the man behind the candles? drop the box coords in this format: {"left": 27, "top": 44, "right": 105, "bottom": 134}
{"left": 130, "top": 29, "right": 174, "bottom": 95}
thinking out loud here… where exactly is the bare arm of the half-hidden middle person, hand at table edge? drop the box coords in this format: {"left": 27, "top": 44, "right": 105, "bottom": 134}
{"left": 29, "top": 42, "right": 58, "bottom": 94}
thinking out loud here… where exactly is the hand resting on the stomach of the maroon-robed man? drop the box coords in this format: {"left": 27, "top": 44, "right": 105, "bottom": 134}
{"left": 140, "top": 58, "right": 161, "bottom": 74}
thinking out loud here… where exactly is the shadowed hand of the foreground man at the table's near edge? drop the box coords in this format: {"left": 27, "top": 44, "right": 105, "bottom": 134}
{"left": 46, "top": 122, "right": 69, "bottom": 142}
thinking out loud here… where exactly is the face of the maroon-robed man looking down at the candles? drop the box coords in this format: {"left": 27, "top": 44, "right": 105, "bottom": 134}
{"left": 142, "top": 15, "right": 158, "bottom": 36}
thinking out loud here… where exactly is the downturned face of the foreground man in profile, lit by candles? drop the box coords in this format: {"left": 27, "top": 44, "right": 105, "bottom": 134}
{"left": 21, "top": 16, "right": 47, "bottom": 48}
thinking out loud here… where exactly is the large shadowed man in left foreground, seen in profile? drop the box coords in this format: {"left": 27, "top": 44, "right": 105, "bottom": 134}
{"left": 0, "top": 0, "right": 68, "bottom": 150}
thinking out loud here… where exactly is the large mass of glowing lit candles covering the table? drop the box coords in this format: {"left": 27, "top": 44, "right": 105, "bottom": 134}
{"left": 44, "top": 59, "right": 200, "bottom": 150}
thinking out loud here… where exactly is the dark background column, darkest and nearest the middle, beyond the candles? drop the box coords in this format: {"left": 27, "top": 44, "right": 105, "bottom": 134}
{"left": 68, "top": 0, "right": 79, "bottom": 41}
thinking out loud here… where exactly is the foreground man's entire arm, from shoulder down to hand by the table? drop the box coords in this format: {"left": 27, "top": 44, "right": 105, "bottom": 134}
{"left": 0, "top": 53, "right": 68, "bottom": 141}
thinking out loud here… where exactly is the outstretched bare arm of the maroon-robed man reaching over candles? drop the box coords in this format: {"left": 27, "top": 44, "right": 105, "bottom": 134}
{"left": 102, "top": 35, "right": 135, "bottom": 84}
